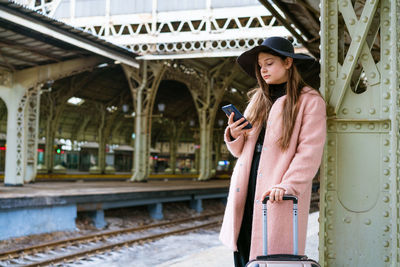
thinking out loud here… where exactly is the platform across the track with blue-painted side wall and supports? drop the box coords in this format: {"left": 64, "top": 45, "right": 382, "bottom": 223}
{"left": 0, "top": 179, "right": 229, "bottom": 240}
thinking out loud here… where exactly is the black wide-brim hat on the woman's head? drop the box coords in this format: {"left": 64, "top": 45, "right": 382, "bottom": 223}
{"left": 237, "top": 37, "right": 319, "bottom": 82}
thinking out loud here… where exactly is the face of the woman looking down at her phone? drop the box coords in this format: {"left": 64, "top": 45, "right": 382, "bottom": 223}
{"left": 258, "top": 52, "right": 293, "bottom": 84}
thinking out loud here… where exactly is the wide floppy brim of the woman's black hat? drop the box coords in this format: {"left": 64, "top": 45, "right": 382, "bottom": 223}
{"left": 236, "top": 45, "right": 318, "bottom": 79}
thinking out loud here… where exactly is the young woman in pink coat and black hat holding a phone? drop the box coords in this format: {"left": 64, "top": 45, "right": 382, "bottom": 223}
{"left": 220, "top": 37, "right": 326, "bottom": 267}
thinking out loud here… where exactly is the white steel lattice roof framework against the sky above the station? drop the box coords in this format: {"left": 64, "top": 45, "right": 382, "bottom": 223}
{"left": 19, "top": 0, "right": 298, "bottom": 60}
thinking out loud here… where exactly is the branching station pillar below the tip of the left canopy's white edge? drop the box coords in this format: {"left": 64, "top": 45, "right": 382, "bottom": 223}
{"left": 122, "top": 60, "right": 166, "bottom": 182}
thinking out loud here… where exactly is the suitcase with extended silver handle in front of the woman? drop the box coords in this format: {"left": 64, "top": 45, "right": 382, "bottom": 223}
{"left": 246, "top": 195, "right": 321, "bottom": 267}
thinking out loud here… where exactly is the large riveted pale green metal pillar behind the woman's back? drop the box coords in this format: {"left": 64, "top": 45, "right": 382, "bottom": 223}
{"left": 319, "top": 0, "right": 400, "bottom": 267}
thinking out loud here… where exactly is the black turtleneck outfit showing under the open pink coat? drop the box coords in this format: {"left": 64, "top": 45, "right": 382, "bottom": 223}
{"left": 237, "top": 83, "right": 286, "bottom": 261}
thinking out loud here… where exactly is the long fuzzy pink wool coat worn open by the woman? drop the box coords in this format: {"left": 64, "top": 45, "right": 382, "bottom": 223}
{"left": 220, "top": 87, "right": 326, "bottom": 260}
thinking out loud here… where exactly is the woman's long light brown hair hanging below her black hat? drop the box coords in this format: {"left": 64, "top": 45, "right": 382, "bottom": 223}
{"left": 245, "top": 51, "right": 306, "bottom": 151}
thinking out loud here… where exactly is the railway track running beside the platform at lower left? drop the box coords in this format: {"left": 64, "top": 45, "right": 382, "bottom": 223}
{"left": 0, "top": 212, "right": 223, "bottom": 266}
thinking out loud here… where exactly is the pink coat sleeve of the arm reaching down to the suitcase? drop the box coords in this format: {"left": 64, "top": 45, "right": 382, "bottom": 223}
{"left": 275, "top": 96, "right": 326, "bottom": 196}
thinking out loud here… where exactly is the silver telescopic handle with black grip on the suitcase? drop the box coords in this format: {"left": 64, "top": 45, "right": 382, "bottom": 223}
{"left": 262, "top": 195, "right": 299, "bottom": 256}
